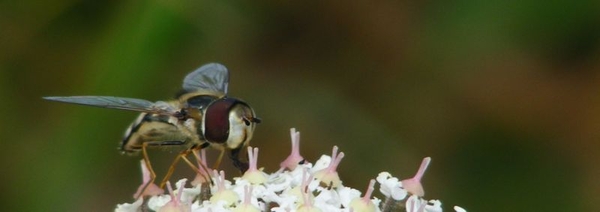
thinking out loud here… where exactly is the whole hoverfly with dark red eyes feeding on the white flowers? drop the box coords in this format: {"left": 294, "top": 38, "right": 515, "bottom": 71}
{"left": 44, "top": 63, "right": 261, "bottom": 193}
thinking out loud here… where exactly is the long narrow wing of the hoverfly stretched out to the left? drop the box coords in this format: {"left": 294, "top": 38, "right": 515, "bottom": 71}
{"left": 44, "top": 96, "right": 178, "bottom": 115}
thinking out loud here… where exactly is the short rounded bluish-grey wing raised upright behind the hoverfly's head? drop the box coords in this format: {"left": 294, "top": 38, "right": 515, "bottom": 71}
{"left": 183, "top": 63, "right": 229, "bottom": 94}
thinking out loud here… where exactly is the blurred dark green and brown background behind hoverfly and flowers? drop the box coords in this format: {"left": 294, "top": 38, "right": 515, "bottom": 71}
{"left": 0, "top": 0, "right": 600, "bottom": 211}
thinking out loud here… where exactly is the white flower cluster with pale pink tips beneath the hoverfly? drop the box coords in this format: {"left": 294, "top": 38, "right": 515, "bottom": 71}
{"left": 115, "top": 129, "right": 465, "bottom": 212}
